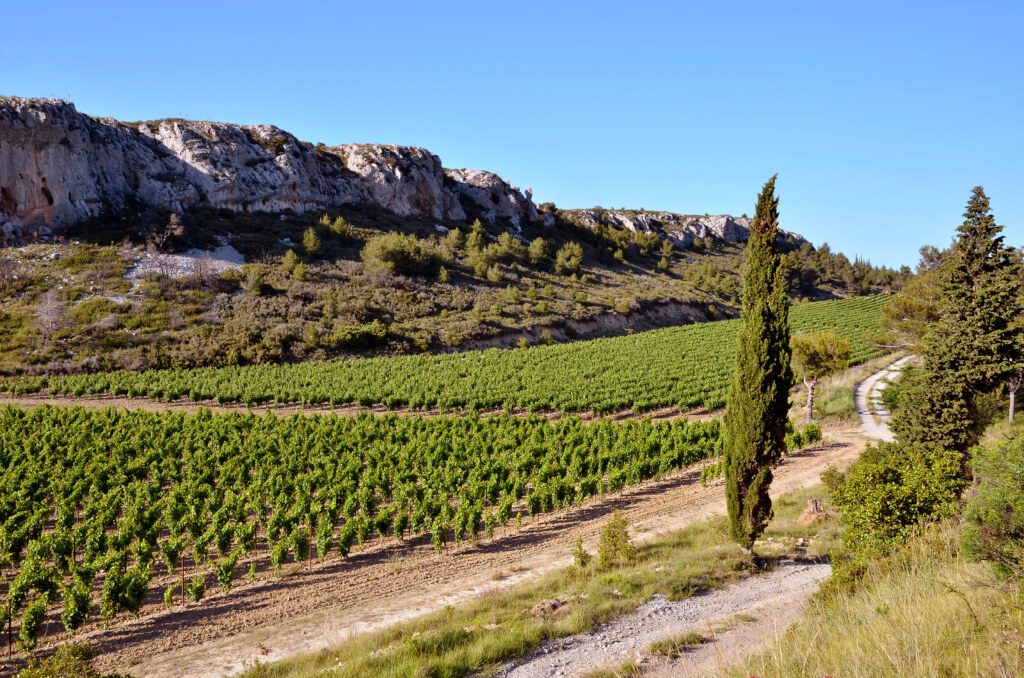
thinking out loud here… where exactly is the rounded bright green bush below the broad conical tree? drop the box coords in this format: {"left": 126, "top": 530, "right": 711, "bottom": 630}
{"left": 823, "top": 442, "right": 965, "bottom": 556}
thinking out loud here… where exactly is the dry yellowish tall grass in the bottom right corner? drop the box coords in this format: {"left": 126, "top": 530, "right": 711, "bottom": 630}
{"left": 719, "top": 525, "right": 1024, "bottom": 678}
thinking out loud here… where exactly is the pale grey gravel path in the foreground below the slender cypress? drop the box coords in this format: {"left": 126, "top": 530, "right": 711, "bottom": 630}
{"left": 498, "top": 563, "right": 831, "bottom": 678}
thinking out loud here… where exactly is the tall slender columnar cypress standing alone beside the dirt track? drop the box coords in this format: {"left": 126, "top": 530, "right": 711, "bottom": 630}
{"left": 724, "top": 176, "right": 793, "bottom": 549}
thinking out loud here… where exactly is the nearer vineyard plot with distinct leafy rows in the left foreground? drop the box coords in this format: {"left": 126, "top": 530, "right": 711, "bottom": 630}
{"left": 0, "top": 407, "right": 720, "bottom": 649}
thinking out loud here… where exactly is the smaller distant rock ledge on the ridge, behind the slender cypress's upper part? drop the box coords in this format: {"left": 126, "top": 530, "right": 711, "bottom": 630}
{"left": 562, "top": 209, "right": 807, "bottom": 248}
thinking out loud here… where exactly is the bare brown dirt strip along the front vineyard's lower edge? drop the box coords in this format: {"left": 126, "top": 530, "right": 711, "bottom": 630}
{"left": 9, "top": 421, "right": 866, "bottom": 676}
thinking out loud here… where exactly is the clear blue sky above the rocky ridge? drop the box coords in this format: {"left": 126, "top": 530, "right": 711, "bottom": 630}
{"left": 0, "top": 0, "right": 1024, "bottom": 265}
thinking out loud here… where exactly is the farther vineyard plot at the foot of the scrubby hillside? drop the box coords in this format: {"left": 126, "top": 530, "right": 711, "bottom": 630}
{"left": 0, "top": 296, "right": 884, "bottom": 413}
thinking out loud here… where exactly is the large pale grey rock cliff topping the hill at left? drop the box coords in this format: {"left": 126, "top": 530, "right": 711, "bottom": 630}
{"left": 0, "top": 97, "right": 538, "bottom": 232}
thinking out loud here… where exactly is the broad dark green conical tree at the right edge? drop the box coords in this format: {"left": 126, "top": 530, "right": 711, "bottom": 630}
{"left": 892, "top": 186, "right": 1022, "bottom": 452}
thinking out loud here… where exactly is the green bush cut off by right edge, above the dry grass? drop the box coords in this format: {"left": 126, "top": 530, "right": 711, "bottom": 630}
{"left": 964, "top": 436, "right": 1024, "bottom": 578}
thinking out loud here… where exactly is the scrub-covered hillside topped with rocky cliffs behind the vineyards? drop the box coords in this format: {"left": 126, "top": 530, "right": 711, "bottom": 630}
{"left": 0, "top": 97, "right": 904, "bottom": 383}
